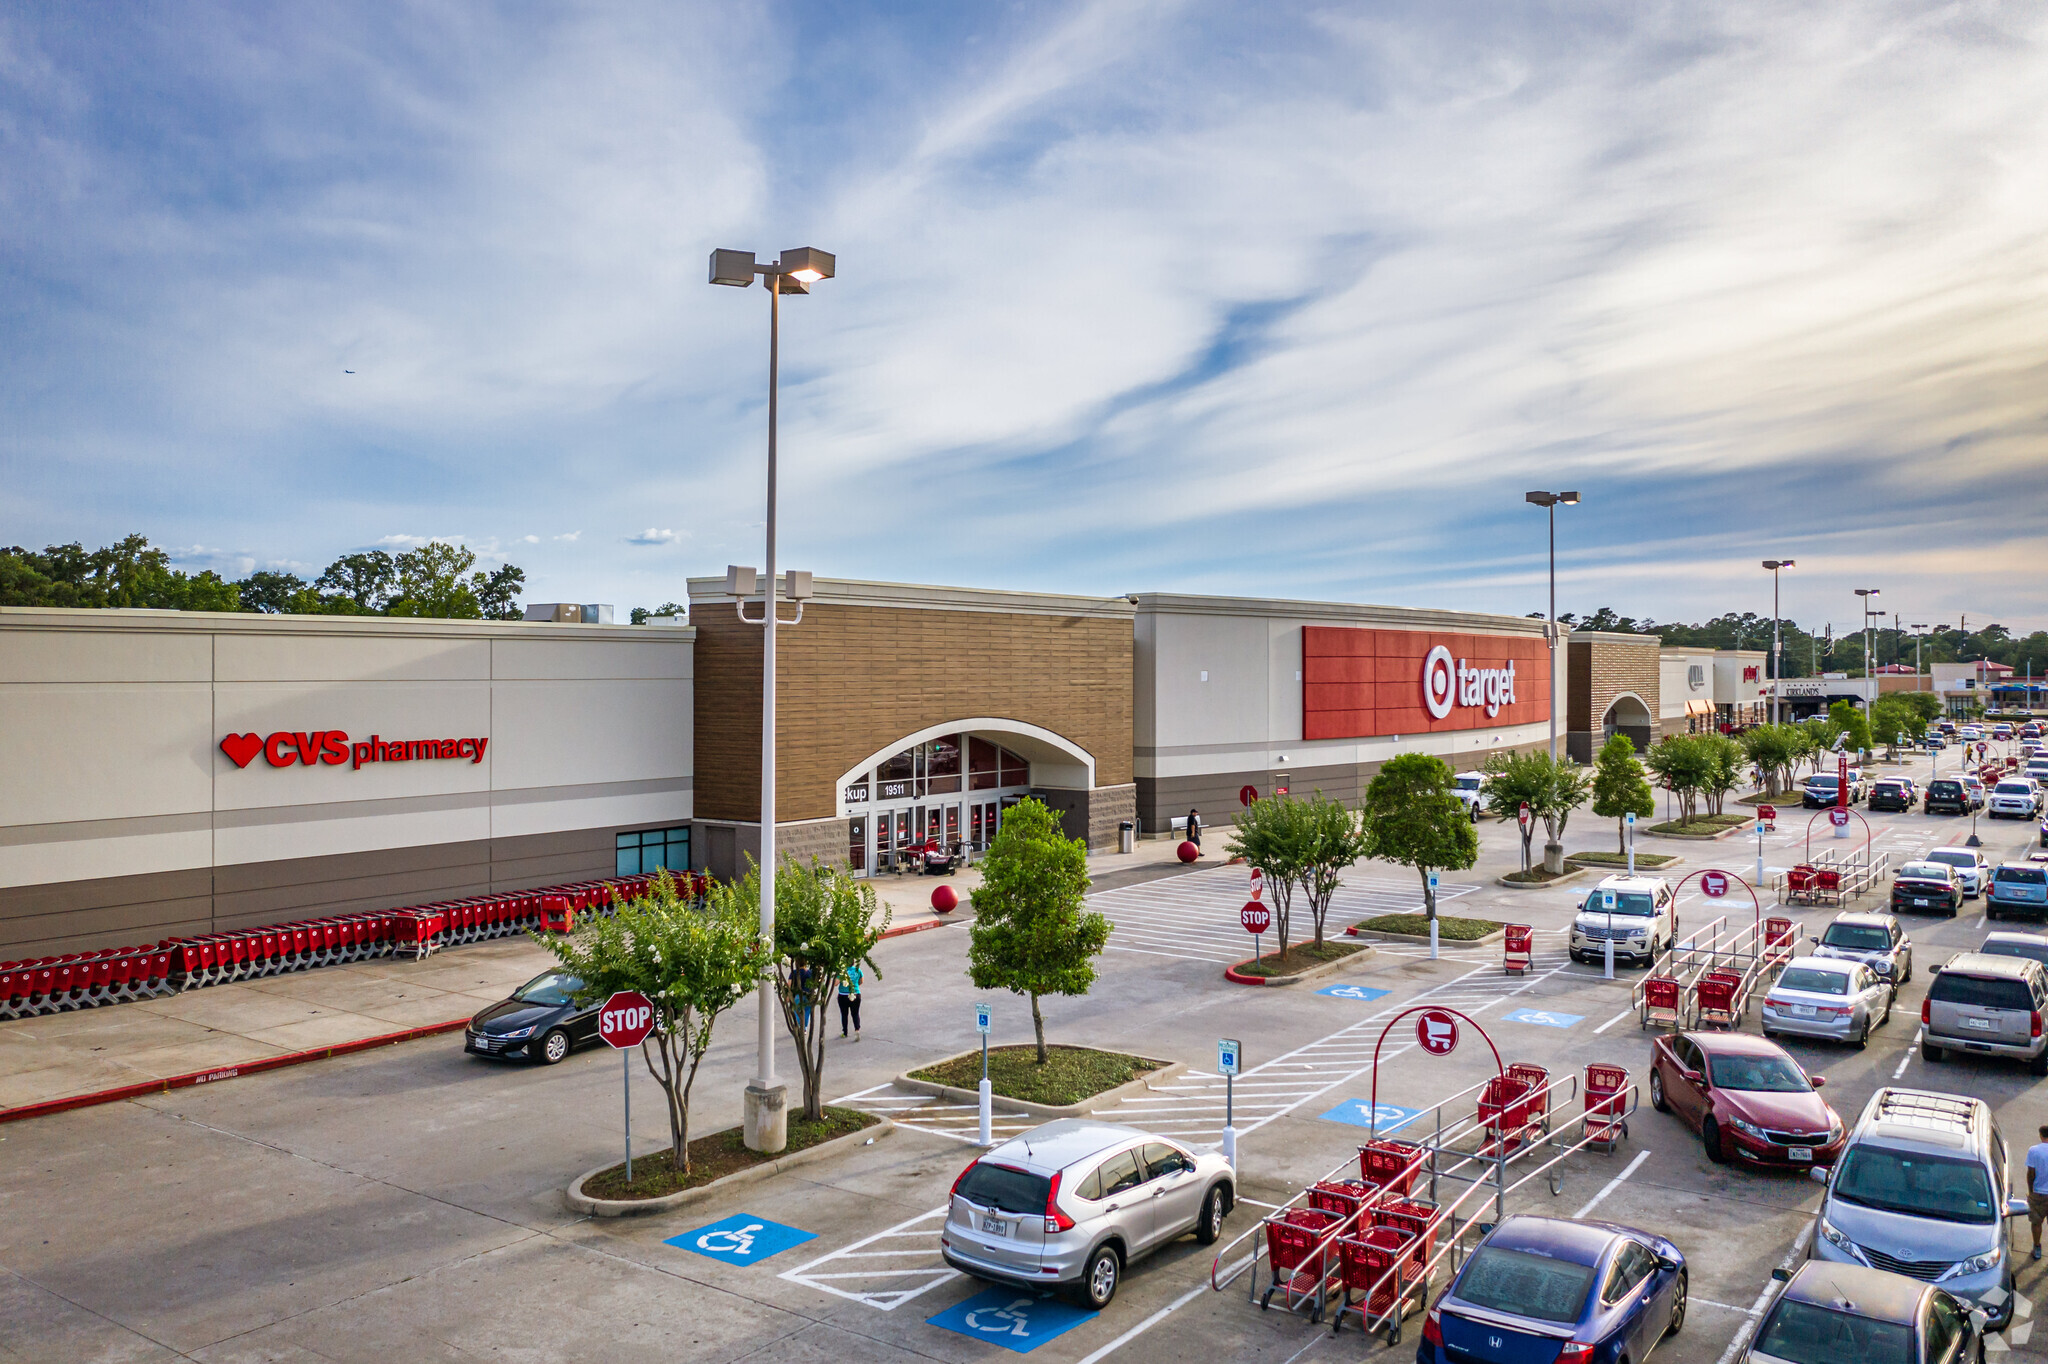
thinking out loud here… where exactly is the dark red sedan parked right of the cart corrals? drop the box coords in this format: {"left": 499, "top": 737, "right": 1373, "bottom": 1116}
{"left": 1651, "top": 1032, "right": 1847, "bottom": 1167}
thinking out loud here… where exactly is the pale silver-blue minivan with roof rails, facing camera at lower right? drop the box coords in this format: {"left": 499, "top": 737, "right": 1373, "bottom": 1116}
{"left": 1808, "top": 1089, "right": 2040, "bottom": 1329}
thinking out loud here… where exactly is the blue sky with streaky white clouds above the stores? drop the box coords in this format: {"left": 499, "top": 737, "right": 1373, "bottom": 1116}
{"left": 0, "top": 0, "right": 2048, "bottom": 631}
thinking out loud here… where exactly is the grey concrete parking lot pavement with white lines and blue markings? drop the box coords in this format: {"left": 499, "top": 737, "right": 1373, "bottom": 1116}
{"left": 0, "top": 758, "right": 2048, "bottom": 1364}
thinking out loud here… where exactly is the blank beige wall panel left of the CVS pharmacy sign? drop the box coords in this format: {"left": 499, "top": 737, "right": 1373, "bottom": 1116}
{"left": 0, "top": 679, "right": 213, "bottom": 825}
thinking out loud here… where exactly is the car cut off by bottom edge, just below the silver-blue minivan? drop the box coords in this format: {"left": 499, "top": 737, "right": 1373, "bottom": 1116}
{"left": 1743, "top": 1260, "right": 1982, "bottom": 1364}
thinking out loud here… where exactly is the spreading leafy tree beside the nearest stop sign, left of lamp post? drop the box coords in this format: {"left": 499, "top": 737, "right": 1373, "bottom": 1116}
{"left": 532, "top": 872, "right": 780, "bottom": 1174}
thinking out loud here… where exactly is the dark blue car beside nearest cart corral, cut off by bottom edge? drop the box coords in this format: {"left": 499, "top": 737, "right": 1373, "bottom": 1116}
{"left": 1415, "top": 1217, "right": 1686, "bottom": 1364}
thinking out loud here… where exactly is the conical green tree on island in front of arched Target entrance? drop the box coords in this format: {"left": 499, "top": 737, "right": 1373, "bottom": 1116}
{"left": 966, "top": 797, "right": 1110, "bottom": 1065}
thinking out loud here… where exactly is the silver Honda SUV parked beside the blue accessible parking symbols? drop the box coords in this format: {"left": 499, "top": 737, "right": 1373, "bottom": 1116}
{"left": 938, "top": 1118, "right": 1235, "bottom": 1311}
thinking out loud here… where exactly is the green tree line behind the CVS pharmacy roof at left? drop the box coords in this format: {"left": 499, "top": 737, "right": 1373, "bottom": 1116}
{"left": 0, "top": 535, "right": 526, "bottom": 621}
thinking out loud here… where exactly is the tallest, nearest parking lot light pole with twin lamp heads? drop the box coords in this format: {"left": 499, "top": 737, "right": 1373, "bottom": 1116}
{"left": 711, "top": 246, "right": 838, "bottom": 1155}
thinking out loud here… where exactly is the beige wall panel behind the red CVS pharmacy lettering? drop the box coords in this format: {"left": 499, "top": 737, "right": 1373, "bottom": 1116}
{"left": 211, "top": 682, "right": 498, "bottom": 806}
